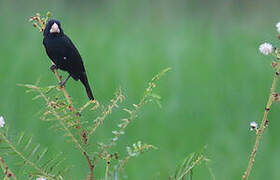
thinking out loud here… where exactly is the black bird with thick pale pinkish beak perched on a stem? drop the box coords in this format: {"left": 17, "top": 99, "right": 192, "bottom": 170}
{"left": 43, "top": 19, "right": 94, "bottom": 100}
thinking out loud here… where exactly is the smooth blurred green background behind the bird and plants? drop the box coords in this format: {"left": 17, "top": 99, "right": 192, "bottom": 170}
{"left": 0, "top": 0, "right": 280, "bottom": 180}
